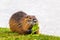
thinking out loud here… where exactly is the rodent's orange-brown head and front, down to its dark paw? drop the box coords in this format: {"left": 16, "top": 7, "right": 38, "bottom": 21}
{"left": 20, "top": 15, "right": 38, "bottom": 34}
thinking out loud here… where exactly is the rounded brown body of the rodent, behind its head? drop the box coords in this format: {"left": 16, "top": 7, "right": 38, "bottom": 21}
{"left": 9, "top": 11, "right": 27, "bottom": 34}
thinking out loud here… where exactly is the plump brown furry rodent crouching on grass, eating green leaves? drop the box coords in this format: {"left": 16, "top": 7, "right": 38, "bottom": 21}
{"left": 9, "top": 11, "right": 39, "bottom": 34}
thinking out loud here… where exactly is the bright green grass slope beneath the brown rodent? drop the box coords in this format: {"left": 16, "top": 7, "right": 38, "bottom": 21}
{"left": 0, "top": 28, "right": 60, "bottom": 40}
